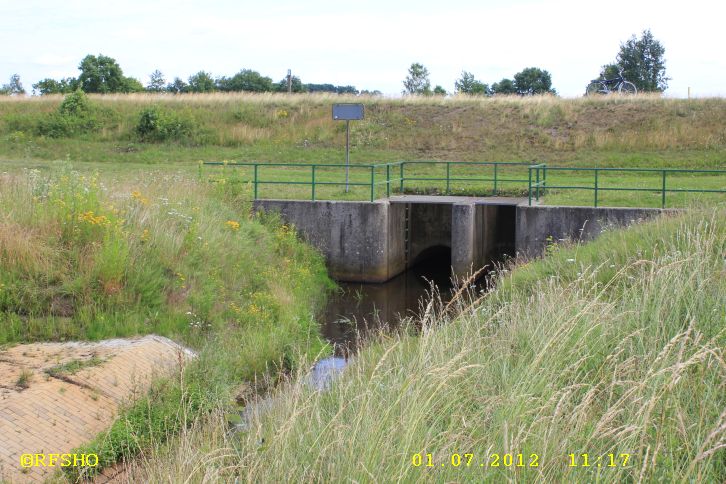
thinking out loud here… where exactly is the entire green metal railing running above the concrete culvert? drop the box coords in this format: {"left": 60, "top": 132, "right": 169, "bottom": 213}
{"left": 199, "top": 161, "right": 726, "bottom": 208}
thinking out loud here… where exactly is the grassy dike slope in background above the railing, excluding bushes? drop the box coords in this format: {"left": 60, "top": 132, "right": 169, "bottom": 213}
{"left": 0, "top": 93, "right": 726, "bottom": 167}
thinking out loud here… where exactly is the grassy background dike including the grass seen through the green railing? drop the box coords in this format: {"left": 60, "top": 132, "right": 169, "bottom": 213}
{"left": 0, "top": 94, "right": 726, "bottom": 206}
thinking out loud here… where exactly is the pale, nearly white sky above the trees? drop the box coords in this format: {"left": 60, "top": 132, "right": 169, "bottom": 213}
{"left": 0, "top": 0, "right": 726, "bottom": 97}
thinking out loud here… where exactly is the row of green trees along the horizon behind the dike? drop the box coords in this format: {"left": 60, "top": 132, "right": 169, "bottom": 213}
{"left": 0, "top": 30, "right": 670, "bottom": 96}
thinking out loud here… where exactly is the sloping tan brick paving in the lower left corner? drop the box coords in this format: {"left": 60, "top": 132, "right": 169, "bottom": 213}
{"left": 0, "top": 336, "right": 194, "bottom": 482}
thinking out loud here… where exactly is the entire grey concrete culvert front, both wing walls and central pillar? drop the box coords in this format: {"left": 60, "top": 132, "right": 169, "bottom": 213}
{"left": 254, "top": 197, "right": 663, "bottom": 282}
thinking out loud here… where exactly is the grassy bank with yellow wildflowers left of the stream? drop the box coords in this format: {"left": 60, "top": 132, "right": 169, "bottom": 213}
{"left": 0, "top": 163, "right": 331, "bottom": 478}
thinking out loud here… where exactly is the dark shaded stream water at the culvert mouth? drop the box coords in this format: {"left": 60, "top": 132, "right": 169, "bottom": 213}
{"left": 320, "top": 254, "right": 452, "bottom": 355}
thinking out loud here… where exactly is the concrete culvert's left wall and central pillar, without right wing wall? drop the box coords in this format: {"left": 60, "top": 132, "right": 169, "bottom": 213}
{"left": 254, "top": 200, "right": 497, "bottom": 282}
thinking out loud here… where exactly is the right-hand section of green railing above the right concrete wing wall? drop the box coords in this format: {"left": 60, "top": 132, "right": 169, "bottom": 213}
{"left": 529, "top": 163, "right": 726, "bottom": 208}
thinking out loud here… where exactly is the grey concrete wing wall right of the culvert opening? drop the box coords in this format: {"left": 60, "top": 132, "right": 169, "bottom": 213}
{"left": 515, "top": 205, "right": 664, "bottom": 257}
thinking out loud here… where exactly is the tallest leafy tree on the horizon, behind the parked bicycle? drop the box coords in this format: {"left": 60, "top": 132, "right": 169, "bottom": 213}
{"left": 616, "top": 30, "right": 670, "bottom": 92}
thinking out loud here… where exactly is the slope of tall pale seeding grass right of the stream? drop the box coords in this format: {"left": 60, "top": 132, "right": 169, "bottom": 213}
{"left": 131, "top": 209, "right": 726, "bottom": 482}
